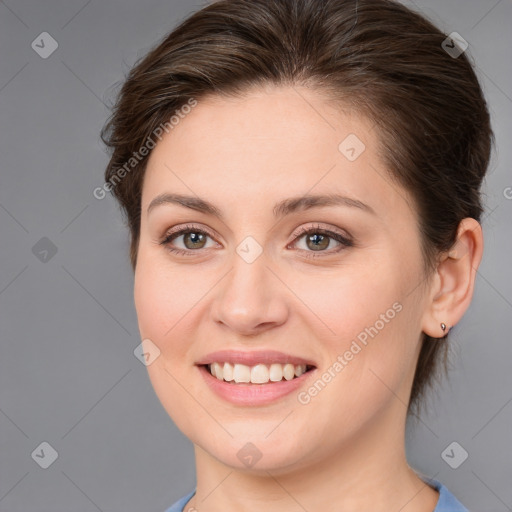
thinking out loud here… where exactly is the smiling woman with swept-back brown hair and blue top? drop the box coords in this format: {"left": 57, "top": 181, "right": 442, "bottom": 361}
{"left": 102, "top": 0, "right": 493, "bottom": 512}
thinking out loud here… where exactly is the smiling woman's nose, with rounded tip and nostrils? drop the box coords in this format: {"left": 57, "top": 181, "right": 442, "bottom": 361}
{"left": 211, "top": 247, "right": 289, "bottom": 336}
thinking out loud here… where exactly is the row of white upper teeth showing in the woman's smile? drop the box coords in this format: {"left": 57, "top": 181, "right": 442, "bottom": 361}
{"left": 208, "top": 363, "right": 306, "bottom": 384}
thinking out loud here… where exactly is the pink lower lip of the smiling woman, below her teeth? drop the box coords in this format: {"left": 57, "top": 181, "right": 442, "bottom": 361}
{"left": 198, "top": 366, "right": 315, "bottom": 405}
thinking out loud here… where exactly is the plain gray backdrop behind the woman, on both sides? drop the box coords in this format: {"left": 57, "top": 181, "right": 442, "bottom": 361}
{"left": 0, "top": 0, "right": 512, "bottom": 512}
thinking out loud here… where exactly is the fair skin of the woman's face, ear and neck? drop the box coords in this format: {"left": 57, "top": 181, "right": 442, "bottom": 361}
{"left": 134, "top": 87, "right": 483, "bottom": 512}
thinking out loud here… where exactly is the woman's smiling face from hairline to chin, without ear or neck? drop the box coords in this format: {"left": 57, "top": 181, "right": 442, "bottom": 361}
{"left": 135, "top": 87, "right": 428, "bottom": 470}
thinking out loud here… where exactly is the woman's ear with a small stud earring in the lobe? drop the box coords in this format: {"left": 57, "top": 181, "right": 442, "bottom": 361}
{"left": 422, "top": 217, "right": 484, "bottom": 338}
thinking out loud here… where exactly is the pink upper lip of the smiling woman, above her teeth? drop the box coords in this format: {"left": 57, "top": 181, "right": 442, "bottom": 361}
{"left": 196, "top": 350, "right": 316, "bottom": 366}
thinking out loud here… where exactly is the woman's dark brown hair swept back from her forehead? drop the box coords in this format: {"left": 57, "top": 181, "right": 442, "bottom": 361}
{"left": 101, "top": 0, "right": 494, "bottom": 413}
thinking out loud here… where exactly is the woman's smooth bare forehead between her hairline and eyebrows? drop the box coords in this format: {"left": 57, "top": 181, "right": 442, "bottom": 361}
{"left": 142, "top": 86, "right": 410, "bottom": 222}
